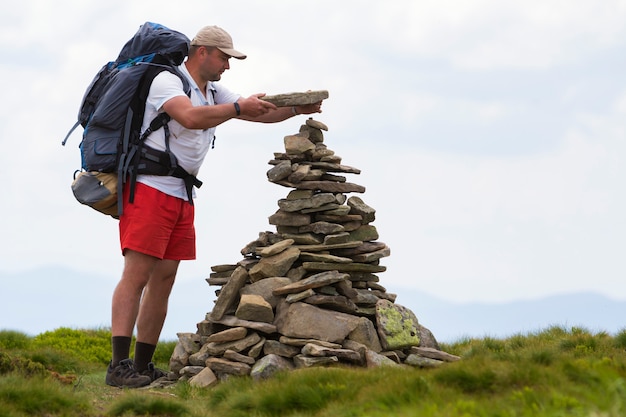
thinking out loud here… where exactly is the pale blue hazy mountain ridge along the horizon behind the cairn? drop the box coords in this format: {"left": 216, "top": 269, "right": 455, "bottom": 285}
{"left": 0, "top": 266, "right": 626, "bottom": 342}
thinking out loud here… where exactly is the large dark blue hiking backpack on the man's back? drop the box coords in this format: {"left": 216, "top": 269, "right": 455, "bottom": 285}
{"left": 62, "top": 22, "right": 202, "bottom": 218}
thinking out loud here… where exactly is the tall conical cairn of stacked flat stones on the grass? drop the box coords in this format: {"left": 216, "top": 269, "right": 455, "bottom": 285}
{"left": 169, "top": 92, "right": 459, "bottom": 386}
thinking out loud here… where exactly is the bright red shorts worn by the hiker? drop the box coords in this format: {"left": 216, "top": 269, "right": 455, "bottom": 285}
{"left": 119, "top": 182, "right": 196, "bottom": 261}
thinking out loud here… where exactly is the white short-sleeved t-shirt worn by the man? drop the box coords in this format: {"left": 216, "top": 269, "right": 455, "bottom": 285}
{"left": 137, "top": 63, "right": 240, "bottom": 200}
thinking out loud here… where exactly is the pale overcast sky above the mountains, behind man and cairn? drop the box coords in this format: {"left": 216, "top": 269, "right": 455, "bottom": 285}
{"left": 0, "top": 0, "right": 626, "bottom": 338}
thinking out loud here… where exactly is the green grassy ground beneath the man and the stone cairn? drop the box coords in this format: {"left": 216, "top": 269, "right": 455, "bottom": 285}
{"left": 0, "top": 326, "right": 626, "bottom": 417}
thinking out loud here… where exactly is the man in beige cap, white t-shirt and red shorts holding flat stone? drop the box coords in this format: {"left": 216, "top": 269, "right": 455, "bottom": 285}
{"left": 106, "top": 26, "right": 321, "bottom": 388}
